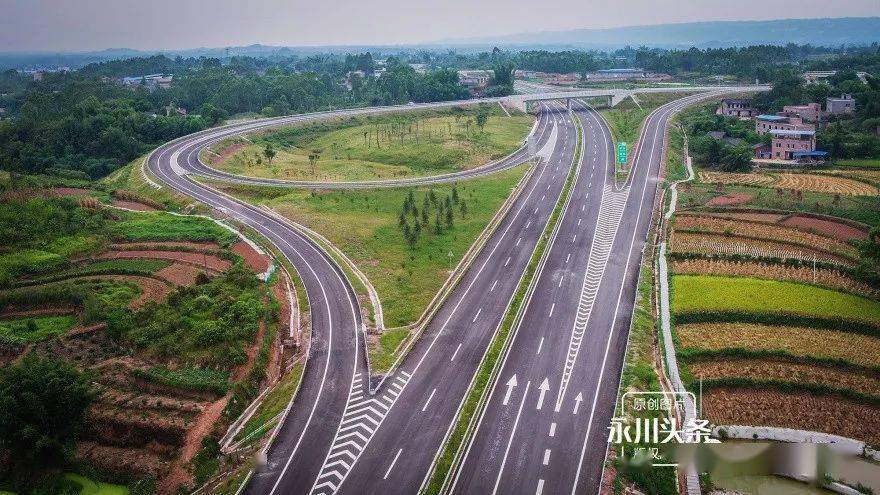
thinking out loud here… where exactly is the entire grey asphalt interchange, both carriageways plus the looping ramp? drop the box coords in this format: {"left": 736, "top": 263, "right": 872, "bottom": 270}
{"left": 147, "top": 87, "right": 748, "bottom": 495}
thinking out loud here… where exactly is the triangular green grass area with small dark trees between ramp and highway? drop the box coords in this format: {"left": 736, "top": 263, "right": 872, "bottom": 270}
{"left": 225, "top": 165, "right": 526, "bottom": 328}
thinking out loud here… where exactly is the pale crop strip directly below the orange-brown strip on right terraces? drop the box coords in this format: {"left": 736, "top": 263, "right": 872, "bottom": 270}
{"left": 670, "top": 232, "right": 856, "bottom": 267}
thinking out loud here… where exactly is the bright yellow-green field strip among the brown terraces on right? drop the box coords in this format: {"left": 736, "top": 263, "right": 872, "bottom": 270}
{"left": 672, "top": 275, "right": 880, "bottom": 324}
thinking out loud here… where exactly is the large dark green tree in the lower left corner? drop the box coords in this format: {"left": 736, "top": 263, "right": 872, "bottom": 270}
{"left": 0, "top": 354, "right": 94, "bottom": 482}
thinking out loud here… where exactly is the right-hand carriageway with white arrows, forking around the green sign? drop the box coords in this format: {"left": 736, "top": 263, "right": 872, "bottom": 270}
{"left": 452, "top": 90, "right": 724, "bottom": 495}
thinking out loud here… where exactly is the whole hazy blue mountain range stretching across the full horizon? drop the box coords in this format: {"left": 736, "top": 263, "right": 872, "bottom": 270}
{"left": 0, "top": 17, "right": 880, "bottom": 69}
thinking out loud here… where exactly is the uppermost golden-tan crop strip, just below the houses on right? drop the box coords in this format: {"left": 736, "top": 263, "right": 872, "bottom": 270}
{"left": 699, "top": 171, "right": 880, "bottom": 196}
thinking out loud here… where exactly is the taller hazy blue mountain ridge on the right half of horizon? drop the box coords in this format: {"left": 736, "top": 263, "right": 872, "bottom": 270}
{"left": 440, "top": 17, "right": 880, "bottom": 48}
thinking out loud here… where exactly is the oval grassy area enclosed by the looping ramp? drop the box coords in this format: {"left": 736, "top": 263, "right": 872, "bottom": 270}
{"left": 210, "top": 106, "right": 534, "bottom": 181}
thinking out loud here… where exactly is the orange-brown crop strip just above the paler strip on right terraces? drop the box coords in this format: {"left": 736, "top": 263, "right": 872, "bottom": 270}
{"left": 675, "top": 215, "right": 859, "bottom": 259}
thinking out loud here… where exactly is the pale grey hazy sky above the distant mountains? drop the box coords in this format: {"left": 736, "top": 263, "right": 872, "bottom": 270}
{"left": 0, "top": 0, "right": 880, "bottom": 52}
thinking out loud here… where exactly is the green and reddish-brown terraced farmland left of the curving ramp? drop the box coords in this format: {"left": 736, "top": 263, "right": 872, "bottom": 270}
{"left": 0, "top": 194, "right": 296, "bottom": 495}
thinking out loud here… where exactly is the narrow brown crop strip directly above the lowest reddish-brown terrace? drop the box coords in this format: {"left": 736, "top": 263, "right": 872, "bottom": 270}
{"left": 688, "top": 357, "right": 880, "bottom": 397}
